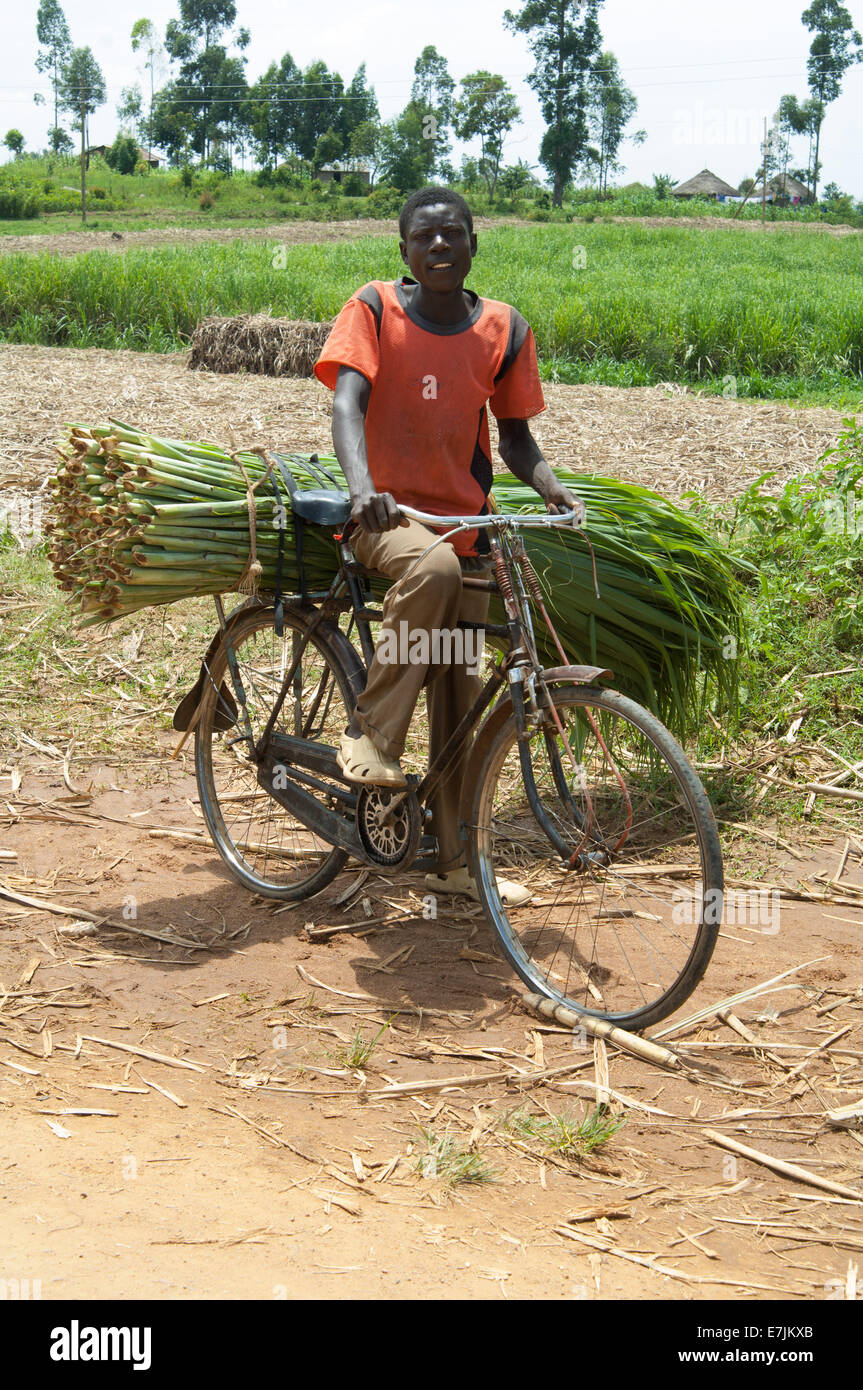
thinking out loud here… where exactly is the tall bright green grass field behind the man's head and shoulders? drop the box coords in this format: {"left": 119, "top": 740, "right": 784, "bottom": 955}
{"left": 0, "top": 224, "right": 863, "bottom": 407}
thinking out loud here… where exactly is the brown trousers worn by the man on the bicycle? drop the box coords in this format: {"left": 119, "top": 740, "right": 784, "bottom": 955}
{"left": 353, "top": 521, "right": 489, "bottom": 870}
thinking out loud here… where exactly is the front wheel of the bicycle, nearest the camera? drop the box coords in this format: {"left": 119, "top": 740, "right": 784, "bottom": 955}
{"left": 468, "top": 685, "right": 723, "bottom": 1029}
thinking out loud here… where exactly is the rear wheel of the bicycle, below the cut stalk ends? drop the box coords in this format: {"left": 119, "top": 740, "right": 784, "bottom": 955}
{"left": 195, "top": 606, "right": 364, "bottom": 901}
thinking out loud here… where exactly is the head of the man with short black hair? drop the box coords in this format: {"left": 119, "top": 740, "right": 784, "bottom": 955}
{"left": 399, "top": 186, "right": 477, "bottom": 292}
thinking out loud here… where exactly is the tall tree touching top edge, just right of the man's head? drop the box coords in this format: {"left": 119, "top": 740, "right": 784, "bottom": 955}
{"left": 503, "top": 0, "right": 603, "bottom": 207}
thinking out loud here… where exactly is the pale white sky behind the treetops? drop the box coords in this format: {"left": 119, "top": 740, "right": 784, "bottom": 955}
{"left": 0, "top": 0, "right": 863, "bottom": 197}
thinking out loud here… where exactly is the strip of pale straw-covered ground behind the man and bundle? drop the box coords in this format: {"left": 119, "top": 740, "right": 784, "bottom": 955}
{"left": 0, "top": 345, "right": 842, "bottom": 511}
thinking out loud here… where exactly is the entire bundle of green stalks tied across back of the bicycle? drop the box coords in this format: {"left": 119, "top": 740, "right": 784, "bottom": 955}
{"left": 50, "top": 421, "right": 742, "bottom": 731}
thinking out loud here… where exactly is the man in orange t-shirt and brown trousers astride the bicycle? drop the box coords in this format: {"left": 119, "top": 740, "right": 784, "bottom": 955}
{"left": 314, "top": 186, "right": 582, "bottom": 901}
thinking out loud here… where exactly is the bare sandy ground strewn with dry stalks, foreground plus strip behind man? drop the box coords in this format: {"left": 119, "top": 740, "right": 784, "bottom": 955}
{"left": 0, "top": 348, "right": 863, "bottom": 1301}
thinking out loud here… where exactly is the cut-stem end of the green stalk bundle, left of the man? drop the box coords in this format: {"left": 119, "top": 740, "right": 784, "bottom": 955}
{"left": 50, "top": 421, "right": 338, "bottom": 627}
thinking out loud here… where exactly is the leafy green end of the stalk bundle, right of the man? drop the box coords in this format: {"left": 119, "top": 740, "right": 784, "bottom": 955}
{"left": 495, "top": 468, "right": 745, "bottom": 734}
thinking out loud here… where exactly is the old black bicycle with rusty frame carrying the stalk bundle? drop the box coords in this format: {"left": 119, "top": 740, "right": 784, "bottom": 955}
{"left": 186, "top": 489, "right": 723, "bottom": 1030}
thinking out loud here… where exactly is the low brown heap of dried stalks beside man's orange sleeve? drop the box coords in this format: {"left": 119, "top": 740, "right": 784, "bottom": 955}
{"left": 188, "top": 314, "right": 332, "bottom": 377}
